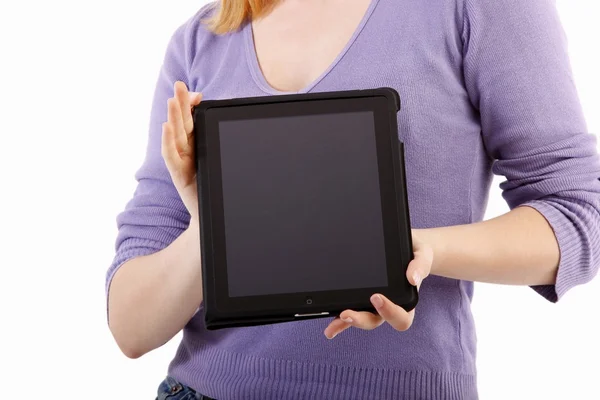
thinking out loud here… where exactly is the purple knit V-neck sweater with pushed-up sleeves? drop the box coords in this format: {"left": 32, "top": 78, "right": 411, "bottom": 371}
{"left": 106, "top": 0, "right": 600, "bottom": 400}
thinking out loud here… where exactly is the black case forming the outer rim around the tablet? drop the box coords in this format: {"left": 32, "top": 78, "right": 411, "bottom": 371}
{"left": 193, "top": 87, "right": 419, "bottom": 330}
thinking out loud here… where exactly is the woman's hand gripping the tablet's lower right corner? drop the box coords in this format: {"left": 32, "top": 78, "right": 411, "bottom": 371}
{"left": 325, "top": 230, "right": 433, "bottom": 339}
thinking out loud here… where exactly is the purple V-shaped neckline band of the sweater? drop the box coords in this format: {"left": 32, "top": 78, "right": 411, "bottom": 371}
{"left": 242, "top": 0, "right": 379, "bottom": 95}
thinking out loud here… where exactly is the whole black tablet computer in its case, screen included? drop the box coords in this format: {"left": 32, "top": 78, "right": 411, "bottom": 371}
{"left": 193, "top": 88, "right": 417, "bottom": 329}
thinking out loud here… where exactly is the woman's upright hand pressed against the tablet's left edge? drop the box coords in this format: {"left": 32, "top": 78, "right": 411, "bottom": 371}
{"left": 162, "top": 81, "right": 202, "bottom": 225}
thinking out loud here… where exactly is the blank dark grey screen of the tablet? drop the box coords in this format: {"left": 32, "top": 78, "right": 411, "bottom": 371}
{"left": 219, "top": 111, "right": 387, "bottom": 297}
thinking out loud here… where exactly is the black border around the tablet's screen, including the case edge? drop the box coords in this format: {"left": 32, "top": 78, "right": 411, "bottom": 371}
{"left": 194, "top": 90, "right": 417, "bottom": 326}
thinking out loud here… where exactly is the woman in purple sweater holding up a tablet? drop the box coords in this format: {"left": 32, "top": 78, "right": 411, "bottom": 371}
{"left": 107, "top": 0, "right": 600, "bottom": 400}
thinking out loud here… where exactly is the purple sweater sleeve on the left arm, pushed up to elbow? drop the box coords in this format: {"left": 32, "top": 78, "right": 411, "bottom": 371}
{"left": 106, "top": 24, "right": 190, "bottom": 296}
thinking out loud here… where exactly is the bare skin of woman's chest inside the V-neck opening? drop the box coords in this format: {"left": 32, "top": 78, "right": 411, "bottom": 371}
{"left": 250, "top": 0, "right": 378, "bottom": 92}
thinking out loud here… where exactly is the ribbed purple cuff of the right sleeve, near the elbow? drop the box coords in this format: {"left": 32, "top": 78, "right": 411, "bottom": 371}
{"left": 521, "top": 200, "right": 587, "bottom": 303}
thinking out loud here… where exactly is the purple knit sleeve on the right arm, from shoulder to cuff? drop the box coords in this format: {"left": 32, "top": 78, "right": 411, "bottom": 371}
{"left": 463, "top": 0, "right": 600, "bottom": 302}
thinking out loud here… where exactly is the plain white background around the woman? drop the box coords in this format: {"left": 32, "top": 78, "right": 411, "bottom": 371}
{"left": 0, "top": 0, "right": 600, "bottom": 400}
